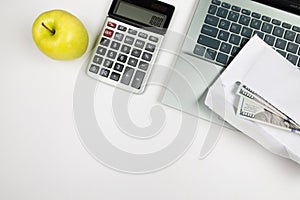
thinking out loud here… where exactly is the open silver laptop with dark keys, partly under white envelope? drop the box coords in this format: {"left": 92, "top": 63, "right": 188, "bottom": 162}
{"left": 162, "top": 0, "right": 300, "bottom": 124}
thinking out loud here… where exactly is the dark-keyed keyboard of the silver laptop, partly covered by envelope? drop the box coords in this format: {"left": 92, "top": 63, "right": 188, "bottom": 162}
{"left": 193, "top": 0, "right": 300, "bottom": 67}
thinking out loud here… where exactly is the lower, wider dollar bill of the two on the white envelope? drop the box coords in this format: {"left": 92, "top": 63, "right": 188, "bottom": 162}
{"left": 237, "top": 96, "right": 300, "bottom": 133}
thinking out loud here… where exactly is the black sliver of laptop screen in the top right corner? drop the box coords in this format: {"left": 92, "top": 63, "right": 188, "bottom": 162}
{"left": 254, "top": 0, "right": 300, "bottom": 15}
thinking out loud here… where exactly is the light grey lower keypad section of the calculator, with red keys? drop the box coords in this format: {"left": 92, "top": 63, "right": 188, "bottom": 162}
{"left": 87, "top": 17, "right": 163, "bottom": 93}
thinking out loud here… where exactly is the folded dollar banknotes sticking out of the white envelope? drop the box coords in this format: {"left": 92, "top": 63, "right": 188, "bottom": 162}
{"left": 236, "top": 84, "right": 300, "bottom": 134}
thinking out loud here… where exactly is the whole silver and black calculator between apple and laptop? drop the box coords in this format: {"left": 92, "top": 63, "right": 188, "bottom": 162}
{"left": 87, "top": 0, "right": 175, "bottom": 94}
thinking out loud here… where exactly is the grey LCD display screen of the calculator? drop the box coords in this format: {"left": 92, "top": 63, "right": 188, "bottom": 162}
{"left": 114, "top": 1, "right": 167, "bottom": 28}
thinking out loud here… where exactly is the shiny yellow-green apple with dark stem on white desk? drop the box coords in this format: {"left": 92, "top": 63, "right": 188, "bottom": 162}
{"left": 32, "top": 10, "right": 89, "bottom": 60}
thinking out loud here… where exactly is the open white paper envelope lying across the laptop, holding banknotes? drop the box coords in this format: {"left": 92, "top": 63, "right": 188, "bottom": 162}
{"left": 205, "top": 36, "right": 300, "bottom": 164}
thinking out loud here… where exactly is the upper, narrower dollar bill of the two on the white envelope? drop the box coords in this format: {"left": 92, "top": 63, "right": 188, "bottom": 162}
{"left": 236, "top": 84, "right": 300, "bottom": 128}
